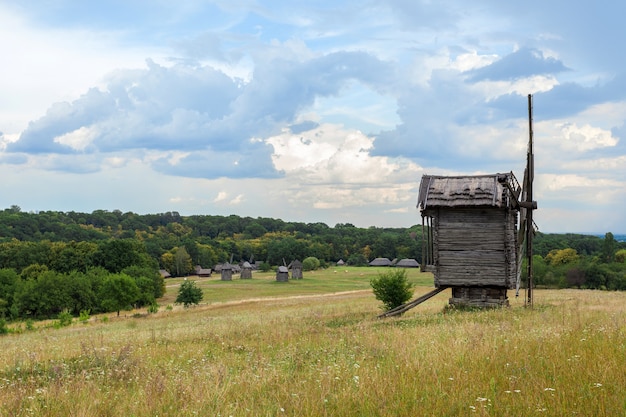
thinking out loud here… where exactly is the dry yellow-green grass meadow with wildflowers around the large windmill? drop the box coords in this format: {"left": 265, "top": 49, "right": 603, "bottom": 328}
{"left": 0, "top": 268, "right": 626, "bottom": 416}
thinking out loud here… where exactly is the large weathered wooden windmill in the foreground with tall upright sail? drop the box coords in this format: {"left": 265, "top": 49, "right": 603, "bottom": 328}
{"left": 379, "top": 95, "right": 537, "bottom": 317}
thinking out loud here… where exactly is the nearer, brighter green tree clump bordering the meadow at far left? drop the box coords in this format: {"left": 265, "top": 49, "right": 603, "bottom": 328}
{"left": 0, "top": 239, "right": 165, "bottom": 319}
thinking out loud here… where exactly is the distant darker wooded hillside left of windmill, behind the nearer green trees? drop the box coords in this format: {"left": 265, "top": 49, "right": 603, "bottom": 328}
{"left": 0, "top": 206, "right": 421, "bottom": 275}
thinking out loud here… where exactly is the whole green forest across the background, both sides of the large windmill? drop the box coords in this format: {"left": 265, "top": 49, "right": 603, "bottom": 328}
{"left": 0, "top": 206, "right": 626, "bottom": 319}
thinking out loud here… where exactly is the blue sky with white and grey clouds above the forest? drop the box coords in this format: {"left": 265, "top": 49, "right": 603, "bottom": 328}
{"left": 0, "top": 0, "right": 626, "bottom": 234}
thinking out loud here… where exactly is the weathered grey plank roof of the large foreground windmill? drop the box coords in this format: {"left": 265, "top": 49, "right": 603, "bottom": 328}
{"left": 417, "top": 173, "right": 517, "bottom": 209}
